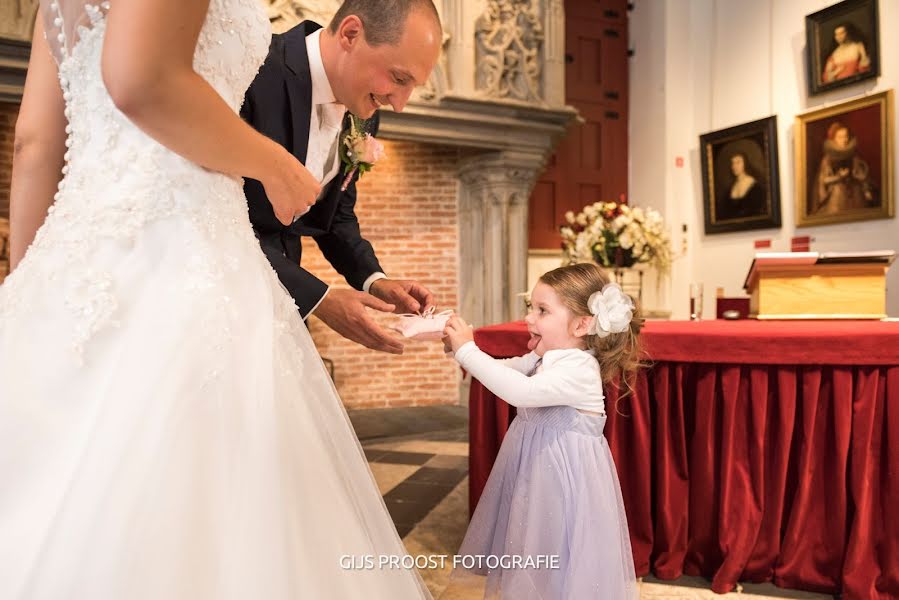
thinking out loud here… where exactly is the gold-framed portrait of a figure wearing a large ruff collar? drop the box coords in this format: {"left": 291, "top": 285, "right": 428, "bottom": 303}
{"left": 795, "top": 90, "right": 894, "bottom": 227}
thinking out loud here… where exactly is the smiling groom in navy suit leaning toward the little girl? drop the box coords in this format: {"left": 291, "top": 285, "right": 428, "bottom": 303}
{"left": 241, "top": 0, "right": 442, "bottom": 354}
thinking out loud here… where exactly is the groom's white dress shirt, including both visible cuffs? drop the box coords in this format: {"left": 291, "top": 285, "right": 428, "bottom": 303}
{"left": 306, "top": 29, "right": 387, "bottom": 314}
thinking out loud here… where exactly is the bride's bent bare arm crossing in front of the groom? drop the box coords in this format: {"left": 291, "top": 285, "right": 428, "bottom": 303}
{"left": 102, "top": 0, "right": 320, "bottom": 224}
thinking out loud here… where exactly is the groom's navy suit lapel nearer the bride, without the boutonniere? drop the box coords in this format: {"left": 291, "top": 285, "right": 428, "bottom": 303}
{"left": 283, "top": 21, "right": 321, "bottom": 164}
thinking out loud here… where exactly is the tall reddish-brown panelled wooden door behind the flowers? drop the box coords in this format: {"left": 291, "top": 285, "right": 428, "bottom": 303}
{"left": 528, "top": 0, "right": 628, "bottom": 249}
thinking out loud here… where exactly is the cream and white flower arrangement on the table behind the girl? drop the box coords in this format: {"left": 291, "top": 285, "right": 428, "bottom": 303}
{"left": 561, "top": 202, "right": 672, "bottom": 273}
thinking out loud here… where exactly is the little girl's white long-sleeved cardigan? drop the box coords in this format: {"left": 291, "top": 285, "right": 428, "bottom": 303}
{"left": 454, "top": 342, "right": 605, "bottom": 414}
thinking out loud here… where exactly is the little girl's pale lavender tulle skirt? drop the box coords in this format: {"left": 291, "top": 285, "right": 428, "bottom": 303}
{"left": 453, "top": 406, "right": 638, "bottom": 600}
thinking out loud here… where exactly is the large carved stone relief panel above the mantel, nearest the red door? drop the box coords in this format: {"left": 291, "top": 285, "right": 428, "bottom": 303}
{"left": 475, "top": 0, "right": 544, "bottom": 102}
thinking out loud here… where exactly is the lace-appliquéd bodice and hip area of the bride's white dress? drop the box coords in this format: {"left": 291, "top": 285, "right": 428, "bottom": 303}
{"left": 0, "top": 0, "right": 271, "bottom": 359}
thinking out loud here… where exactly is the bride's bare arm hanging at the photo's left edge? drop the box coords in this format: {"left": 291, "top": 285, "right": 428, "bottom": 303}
{"left": 9, "top": 18, "right": 66, "bottom": 269}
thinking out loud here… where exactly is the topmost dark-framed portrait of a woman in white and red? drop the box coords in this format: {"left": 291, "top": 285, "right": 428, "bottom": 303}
{"left": 805, "top": 0, "right": 880, "bottom": 95}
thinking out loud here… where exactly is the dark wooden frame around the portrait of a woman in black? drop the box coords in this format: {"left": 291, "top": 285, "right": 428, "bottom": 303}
{"left": 699, "top": 116, "right": 781, "bottom": 235}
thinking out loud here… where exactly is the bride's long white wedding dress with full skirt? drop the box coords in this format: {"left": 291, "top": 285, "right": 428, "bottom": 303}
{"left": 0, "top": 0, "right": 430, "bottom": 600}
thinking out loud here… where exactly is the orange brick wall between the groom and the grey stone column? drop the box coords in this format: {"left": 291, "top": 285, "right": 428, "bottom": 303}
{"left": 303, "top": 142, "right": 460, "bottom": 408}
